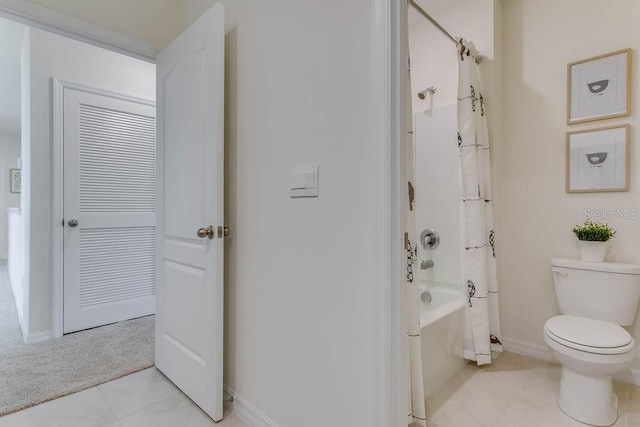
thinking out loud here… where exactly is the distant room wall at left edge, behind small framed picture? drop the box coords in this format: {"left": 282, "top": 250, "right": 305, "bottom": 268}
{"left": 0, "top": 134, "right": 20, "bottom": 259}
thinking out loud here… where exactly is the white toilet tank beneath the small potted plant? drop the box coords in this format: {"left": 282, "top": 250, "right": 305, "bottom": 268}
{"left": 551, "top": 258, "right": 640, "bottom": 326}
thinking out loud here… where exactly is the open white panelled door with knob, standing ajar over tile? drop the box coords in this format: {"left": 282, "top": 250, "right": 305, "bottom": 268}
{"left": 156, "top": 4, "right": 224, "bottom": 421}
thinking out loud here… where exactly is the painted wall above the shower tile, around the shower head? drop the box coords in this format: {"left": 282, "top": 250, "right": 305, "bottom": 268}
{"left": 409, "top": 0, "right": 495, "bottom": 112}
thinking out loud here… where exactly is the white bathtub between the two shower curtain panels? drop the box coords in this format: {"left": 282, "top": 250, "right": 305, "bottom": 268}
{"left": 419, "top": 282, "right": 466, "bottom": 399}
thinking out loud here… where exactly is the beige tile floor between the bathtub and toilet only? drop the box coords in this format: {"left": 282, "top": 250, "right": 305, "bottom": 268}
{"left": 418, "top": 352, "right": 640, "bottom": 427}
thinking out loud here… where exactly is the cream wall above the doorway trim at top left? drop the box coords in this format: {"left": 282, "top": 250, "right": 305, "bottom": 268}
{"left": 28, "top": 0, "right": 180, "bottom": 49}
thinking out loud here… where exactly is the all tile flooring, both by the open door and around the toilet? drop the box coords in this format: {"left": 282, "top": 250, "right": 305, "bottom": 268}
{"left": 5, "top": 352, "right": 640, "bottom": 427}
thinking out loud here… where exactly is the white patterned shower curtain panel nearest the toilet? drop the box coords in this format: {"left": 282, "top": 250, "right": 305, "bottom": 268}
{"left": 458, "top": 39, "right": 502, "bottom": 365}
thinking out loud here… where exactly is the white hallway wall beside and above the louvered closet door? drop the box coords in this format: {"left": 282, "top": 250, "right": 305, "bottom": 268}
{"left": 22, "top": 29, "right": 155, "bottom": 340}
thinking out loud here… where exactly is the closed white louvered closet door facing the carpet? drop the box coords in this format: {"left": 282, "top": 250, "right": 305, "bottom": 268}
{"left": 64, "top": 88, "right": 156, "bottom": 333}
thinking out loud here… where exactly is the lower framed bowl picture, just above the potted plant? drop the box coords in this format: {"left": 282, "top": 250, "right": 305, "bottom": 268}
{"left": 567, "top": 125, "right": 629, "bottom": 193}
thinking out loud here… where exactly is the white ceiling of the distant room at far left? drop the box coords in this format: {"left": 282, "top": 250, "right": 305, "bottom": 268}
{"left": 0, "top": 18, "right": 26, "bottom": 135}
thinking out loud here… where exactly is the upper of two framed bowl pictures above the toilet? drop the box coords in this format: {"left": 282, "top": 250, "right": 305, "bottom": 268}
{"left": 567, "top": 49, "right": 631, "bottom": 125}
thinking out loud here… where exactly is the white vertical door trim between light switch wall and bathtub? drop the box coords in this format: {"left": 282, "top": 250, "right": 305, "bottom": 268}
{"left": 370, "top": 0, "right": 409, "bottom": 427}
